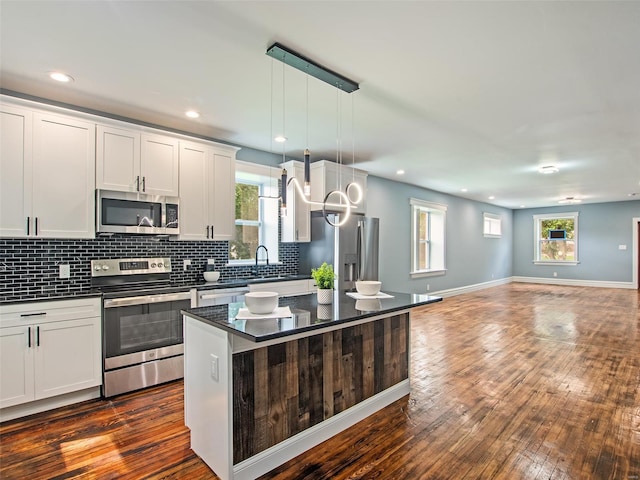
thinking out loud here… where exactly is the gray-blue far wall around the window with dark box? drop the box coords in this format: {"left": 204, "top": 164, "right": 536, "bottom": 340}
{"left": 513, "top": 200, "right": 640, "bottom": 282}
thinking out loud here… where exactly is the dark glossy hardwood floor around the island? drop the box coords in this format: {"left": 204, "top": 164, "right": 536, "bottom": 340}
{"left": 0, "top": 283, "right": 640, "bottom": 480}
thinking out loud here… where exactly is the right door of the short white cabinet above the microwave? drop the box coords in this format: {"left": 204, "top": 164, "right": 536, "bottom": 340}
{"left": 140, "top": 134, "right": 179, "bottom": 197}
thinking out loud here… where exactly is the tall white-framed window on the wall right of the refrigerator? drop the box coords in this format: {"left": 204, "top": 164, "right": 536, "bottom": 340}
{"left": 409, "top": 198, "right": 447, "bottom": 277}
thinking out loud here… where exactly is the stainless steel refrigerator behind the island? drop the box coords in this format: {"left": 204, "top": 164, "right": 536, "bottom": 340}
{"left": 299, "top": 212, "right": 380, "bottom": 291}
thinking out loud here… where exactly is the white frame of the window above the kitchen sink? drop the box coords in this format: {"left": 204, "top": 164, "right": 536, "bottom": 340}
{"left": 227, "top": 160, "right": 280, "bottom": 266}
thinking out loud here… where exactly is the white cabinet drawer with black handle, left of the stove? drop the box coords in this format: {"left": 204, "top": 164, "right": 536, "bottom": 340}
{"left": 0, "top": 297, "right": 101, "bottom": 327}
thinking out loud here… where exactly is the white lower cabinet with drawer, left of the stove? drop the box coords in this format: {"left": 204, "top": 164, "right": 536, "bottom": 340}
{"left": 0, "top": 298, "right": 102, "bottom": 408}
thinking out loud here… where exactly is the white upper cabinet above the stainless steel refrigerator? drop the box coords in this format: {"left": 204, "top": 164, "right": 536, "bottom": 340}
{"left": 311, "top": 160, "right": 368, "bottom": 213}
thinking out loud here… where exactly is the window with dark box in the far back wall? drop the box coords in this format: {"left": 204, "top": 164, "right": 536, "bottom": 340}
{"left": 533, "top": 212, "right": 578, "bottom": 265}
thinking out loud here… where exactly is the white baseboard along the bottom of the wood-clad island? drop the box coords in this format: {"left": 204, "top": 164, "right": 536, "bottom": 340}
{"left": 233, "top": 379, "right": 411, "bottom": 480}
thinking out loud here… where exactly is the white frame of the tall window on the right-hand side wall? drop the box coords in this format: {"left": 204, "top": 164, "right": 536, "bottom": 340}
{"left": 409, "top": 198, "right": 447, "bottom": 278}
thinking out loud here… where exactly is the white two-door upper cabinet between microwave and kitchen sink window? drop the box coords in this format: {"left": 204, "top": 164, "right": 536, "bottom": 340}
{"left": 180, "top": 142, "right": 238, "bottom": 240}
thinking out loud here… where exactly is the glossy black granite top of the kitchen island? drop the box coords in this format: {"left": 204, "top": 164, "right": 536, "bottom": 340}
{"left": 182, "top": 292, "right": 442, "bottom": 342}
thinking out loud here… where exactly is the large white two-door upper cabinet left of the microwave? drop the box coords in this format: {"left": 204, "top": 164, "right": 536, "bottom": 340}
{"left": 0, "top": 104, "right": 95, "bottom": 238}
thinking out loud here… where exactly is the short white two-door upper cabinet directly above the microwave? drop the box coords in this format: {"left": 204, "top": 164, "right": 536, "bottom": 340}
{"left": 96, "top": 125, "right": 179, "bottom": 197}
